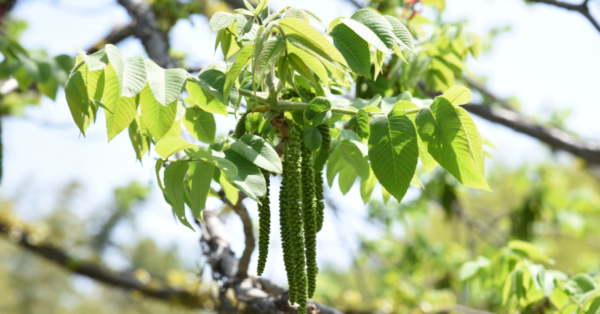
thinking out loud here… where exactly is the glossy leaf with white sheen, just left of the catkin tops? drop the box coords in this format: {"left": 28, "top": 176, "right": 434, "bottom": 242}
{"left": 230, "top": 134, "right": 283, "bottom": 173}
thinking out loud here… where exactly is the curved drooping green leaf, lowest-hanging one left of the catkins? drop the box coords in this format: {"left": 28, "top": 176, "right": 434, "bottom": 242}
{"left": 165, "top": 162, "right": 195, "bottom": 231}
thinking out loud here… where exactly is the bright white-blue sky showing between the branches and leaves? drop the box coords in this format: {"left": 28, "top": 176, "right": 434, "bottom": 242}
{"left": 0, "top": 0, "right": 600, "bottom": 277}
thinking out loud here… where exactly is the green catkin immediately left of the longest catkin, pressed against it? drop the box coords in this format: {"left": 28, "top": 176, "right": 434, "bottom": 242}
{"left": 279, "top": 156, "right": 296, "bottom": 304}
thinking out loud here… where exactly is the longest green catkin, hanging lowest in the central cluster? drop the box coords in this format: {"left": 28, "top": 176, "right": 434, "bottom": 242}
{"left": 286, "top": 125, "right": 307, "bottom": 313}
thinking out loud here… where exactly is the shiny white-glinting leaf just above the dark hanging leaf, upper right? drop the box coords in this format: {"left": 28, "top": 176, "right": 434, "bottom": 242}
{"left": 342, "top": 9, "right": 397, "bottom": 53}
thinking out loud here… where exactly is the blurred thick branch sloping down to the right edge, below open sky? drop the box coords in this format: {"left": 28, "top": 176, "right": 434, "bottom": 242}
{"left": 462, "top": 104, "right": 600, "bottom": 165}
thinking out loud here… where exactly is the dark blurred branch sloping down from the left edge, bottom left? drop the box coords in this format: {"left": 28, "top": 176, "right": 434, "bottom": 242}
{"left": 0, "top": 221, "right": 205, "bottom": 308}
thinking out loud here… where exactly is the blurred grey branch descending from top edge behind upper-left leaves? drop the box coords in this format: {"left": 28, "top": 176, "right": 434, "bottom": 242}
{"left": 118, "top": 0, "right": 177, "bottom": 68}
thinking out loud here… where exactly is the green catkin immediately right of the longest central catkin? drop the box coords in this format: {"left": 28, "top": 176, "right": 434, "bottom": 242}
{"left": 302, "top": 144, "right": 318, "bottom": 298}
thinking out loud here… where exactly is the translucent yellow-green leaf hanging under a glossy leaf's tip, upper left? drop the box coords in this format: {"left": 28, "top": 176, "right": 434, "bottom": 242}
{"left": 140, "top": 85, "right": 177, "bottom": 141}
